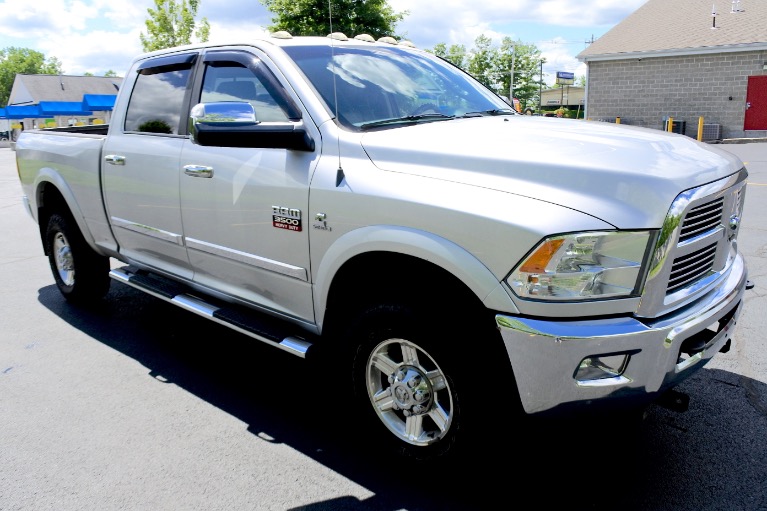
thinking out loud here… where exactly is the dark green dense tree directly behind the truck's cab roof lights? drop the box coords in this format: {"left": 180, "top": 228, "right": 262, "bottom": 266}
{"left": 261, "top": 0, "right": 407, "bottom": 39}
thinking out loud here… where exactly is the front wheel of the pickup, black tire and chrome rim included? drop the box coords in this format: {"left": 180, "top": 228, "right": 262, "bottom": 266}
{"left": 347, "top": 305, "right": 510, "bottom": 463}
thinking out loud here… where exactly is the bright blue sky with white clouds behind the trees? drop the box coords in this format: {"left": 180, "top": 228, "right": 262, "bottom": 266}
{"left": 0, "top": 0, "right": 646, "bottom": 84}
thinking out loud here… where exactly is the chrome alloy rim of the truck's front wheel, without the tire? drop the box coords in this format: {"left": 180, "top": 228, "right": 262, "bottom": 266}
{"left": 366, "top": 339, "right": 453, "bottom": 446}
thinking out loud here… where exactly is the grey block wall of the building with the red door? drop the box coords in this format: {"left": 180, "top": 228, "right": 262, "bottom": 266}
{"left": 586, "top": 51, "right": 767, "bottom": 138}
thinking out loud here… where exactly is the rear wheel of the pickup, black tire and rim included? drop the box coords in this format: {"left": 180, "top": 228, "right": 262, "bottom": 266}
{"left": 45, "top": 213, "right": 111, "bottom": 303}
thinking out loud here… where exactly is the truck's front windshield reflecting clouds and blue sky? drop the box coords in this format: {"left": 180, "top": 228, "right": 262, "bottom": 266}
{"left": 285, "top": 46, "right": 512, "bottom": 130}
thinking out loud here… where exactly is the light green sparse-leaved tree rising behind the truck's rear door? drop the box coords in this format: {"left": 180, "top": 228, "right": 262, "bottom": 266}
{"left": 139, "top": 0, "right": 210, "bottom": 51}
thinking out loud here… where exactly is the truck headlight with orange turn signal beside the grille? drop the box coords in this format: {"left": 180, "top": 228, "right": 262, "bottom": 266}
{"left": 506, "top": 231, "right": 653, "bottom": 301}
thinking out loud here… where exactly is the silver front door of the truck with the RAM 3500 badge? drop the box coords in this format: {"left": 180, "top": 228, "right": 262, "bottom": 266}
{"left": 180, "top": 49, "right": 319, "bottom": 322}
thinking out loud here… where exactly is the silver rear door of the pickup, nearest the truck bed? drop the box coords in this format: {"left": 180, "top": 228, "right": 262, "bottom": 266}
{"left": 102, "top": 53, "right": 198, "bottom": 278}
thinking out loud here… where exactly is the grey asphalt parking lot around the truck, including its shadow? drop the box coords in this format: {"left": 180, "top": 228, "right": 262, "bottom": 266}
{"left": 0, "top": 143, "right": 767, "bottom": 511}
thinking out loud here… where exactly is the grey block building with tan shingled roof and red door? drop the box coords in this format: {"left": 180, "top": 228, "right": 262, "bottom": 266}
{"left": 578, "top": 0, "right": 767, "bottom": 140}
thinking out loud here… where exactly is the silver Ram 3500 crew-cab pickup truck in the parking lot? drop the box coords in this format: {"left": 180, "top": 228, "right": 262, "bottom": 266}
{"left": 16, "top": 33, "right": 747, "bottom": 460}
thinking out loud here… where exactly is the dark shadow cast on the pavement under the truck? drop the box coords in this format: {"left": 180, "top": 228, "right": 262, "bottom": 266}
{"left": 38, "top": 282, "right": 767, "bottom": 511}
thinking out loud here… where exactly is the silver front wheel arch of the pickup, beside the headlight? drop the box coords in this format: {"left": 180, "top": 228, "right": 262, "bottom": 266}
{"left": 314, "top": 226, "right": 516, "bottom": 336}
